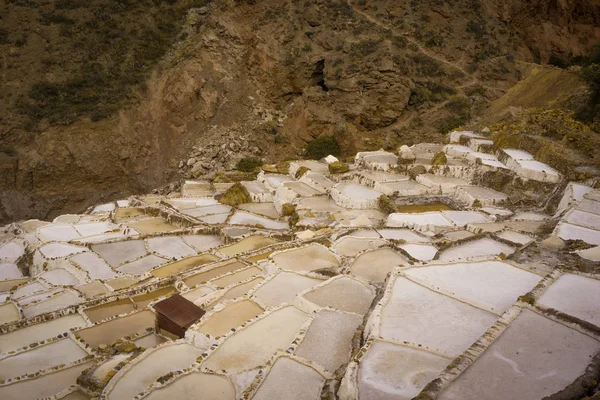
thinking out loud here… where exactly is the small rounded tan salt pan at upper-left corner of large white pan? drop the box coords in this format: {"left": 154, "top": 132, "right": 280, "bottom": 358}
{"left": 350, "top": 249, "right": 408, "bottom": 282}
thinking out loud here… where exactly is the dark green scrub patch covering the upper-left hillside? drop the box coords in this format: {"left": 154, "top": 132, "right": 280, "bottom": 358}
{"left": 9, "top": 0, "right": 209, "bottom": 130}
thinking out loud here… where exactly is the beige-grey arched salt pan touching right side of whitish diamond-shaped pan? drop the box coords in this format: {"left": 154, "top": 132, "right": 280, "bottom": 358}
{"left": 303, "top": 275, "right": 375, "bottom": 315}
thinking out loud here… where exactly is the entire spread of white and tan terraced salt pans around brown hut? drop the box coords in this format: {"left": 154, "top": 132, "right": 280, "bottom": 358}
{"left": 0, "top": 132, "right": 600, "bottom": 400}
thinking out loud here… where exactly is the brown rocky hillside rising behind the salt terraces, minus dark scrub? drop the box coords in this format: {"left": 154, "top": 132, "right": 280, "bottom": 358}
{"left": 0, "top": 0, "right": 600, "bottom": 221}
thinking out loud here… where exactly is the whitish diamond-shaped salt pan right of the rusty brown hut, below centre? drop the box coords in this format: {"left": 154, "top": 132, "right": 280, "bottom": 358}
{"left": 252, "top": 271, "right": 322, "bottom": 307}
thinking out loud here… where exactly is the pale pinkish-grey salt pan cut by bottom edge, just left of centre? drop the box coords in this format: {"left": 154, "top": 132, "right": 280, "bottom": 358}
{"left": 252, "top": 356, "right": 325, "bottom": 400}
